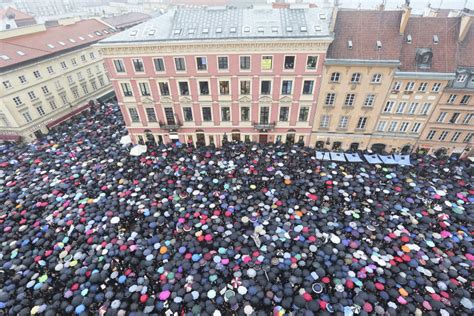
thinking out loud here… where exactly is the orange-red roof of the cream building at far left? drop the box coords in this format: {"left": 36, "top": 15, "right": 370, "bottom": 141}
{"left": 0, "top": 19, "right": 111, "bottom": 70}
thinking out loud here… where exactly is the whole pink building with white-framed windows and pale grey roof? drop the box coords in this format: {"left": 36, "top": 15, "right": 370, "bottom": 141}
{"left": 100, "top": 8, "right": 332, "bottom": 146}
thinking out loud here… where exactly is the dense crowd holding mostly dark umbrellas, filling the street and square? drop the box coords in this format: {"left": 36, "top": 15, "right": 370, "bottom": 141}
{"left": 0, "top": 104, "right": 474, "bottom": 315}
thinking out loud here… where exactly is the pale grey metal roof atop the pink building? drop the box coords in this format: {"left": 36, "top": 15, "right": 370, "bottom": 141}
{"left": 101, "top": 7, "right": 332, "bottom": 44}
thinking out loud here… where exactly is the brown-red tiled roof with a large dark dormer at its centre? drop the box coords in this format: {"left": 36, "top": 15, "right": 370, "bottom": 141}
{"left": 400, "top": 16, "right": 462, "bottom": 73}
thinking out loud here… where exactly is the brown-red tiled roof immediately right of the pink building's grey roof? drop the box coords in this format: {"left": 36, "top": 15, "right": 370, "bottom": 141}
{"left": 327, "top": 10, "right": 402, "bottom": 60}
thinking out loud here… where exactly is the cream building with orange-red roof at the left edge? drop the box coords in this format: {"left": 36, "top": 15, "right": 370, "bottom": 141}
{"left": 0, "top": 20, "right": 113, "bottom": 141}
